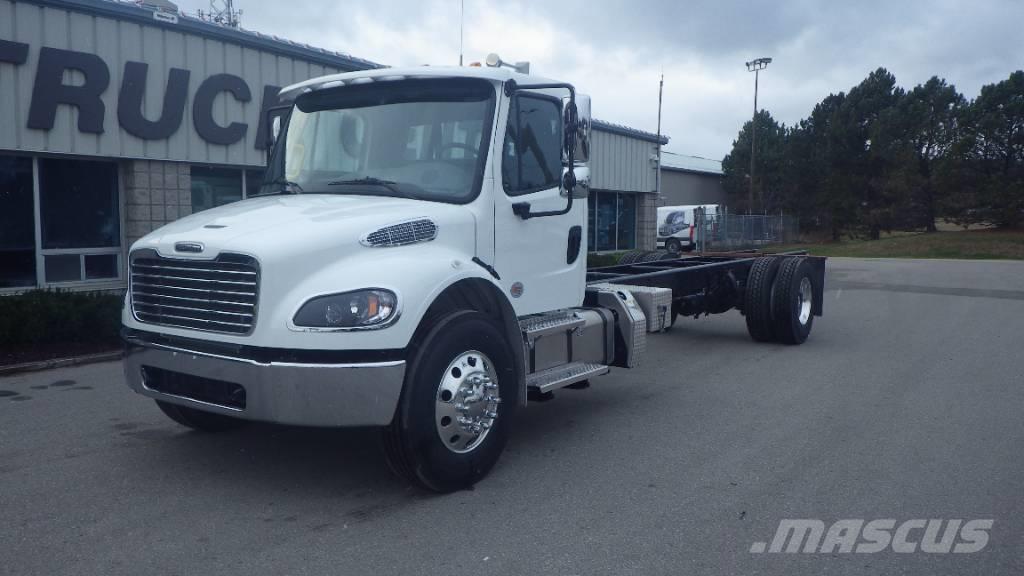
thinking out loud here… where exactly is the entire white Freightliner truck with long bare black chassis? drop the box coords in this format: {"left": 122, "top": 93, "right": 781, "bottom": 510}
{"left": 123, "top": 67, "right": 824, "bottom": 492}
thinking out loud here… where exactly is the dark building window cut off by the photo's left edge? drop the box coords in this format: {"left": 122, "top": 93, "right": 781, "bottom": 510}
{"left": 0, "top": 156, "right": 36, "bottom": 288}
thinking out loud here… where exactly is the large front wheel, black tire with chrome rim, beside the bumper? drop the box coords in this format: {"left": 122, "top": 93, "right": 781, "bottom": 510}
{"left": 384, "top": 311, "right": 519, "bottom": 493}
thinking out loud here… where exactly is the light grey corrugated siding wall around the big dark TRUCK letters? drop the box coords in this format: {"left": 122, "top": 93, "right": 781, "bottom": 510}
{"left": 0, "top": 0, "right": 338, "bottom": 166}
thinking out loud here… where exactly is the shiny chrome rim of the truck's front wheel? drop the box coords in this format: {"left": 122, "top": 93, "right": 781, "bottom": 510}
{"left": 434, "top": 351, "right": 502, "bottom": 454}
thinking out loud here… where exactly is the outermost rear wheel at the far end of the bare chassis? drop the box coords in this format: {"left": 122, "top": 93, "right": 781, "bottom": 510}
{"left": 771, "top": 254, "right": 815, "bottom": 344}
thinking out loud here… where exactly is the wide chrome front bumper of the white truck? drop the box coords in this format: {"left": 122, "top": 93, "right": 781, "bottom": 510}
{"left": 124, "top": 338, "right": 406, "bottom": 426}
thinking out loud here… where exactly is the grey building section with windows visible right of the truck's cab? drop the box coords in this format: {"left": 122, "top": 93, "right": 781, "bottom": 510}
{"left": 587, "top": 120, "right": 669, "bottom": 252}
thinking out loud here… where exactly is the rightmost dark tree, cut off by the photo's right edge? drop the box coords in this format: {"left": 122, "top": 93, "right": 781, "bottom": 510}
{"left": 943, "top": 71, "right": 1024, "bottom": 228}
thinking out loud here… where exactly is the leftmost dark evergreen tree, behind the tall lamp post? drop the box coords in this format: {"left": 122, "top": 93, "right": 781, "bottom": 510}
{"left": 722, "top": 110, "right": 785, "bottom": 212}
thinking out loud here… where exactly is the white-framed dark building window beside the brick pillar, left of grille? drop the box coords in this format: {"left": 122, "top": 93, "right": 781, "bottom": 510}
{"left": 37, "top": 158, "right": 121, "bottom": 284}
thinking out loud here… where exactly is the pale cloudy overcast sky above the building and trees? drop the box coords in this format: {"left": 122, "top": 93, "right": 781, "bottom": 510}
{"left": 178, "top": 0, "right": 1024, "bottom": 159}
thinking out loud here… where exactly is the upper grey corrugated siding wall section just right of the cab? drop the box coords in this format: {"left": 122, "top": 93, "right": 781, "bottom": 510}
{"left": 591, "top": 130, "right": 655, "bottom": 192}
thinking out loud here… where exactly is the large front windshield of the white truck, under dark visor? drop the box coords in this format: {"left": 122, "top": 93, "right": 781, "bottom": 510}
{"left": 261, "top": 79, "right": 495, "bottom": 203}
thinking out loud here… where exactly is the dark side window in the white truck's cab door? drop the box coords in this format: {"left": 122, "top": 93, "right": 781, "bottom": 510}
{"left": 502, "top": 94, "right": 562, "bottom": 196}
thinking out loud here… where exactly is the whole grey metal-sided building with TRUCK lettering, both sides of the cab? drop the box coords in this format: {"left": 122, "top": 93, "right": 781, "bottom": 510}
{"left": 0, "top": 0, "right": 667, "bottom": 292}
